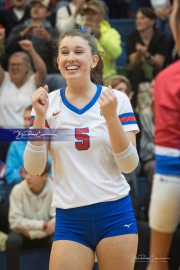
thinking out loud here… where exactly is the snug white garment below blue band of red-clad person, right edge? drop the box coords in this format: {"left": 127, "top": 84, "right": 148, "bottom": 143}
{"left": 149, "top": 174, "right": 180, "bottom": 233}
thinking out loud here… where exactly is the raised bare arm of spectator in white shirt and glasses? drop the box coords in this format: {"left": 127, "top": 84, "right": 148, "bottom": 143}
{"left": 19, "top": 40, "right": 47, "bottom": 87}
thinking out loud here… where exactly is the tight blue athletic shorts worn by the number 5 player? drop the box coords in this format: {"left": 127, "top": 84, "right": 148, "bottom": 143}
{"left": 54, "top": 195, "right": 138, "bottom": 250}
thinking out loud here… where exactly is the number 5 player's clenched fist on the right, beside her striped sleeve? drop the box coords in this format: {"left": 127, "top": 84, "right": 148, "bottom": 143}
{"left": 98, "top": 86, "right": 117, "bottom": 121}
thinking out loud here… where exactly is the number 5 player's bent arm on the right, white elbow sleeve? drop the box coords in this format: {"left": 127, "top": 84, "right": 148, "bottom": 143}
{"left": 99, "top": 87, "right": 139, "bottom": 173}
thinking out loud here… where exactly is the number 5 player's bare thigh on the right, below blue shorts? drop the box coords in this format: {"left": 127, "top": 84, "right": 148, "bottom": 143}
{"left": 96, "top": 234, "right": 138, "bottom": 270}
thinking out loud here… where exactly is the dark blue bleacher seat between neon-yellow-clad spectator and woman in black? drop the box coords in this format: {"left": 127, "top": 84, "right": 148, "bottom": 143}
{"left": 109, "top": 19, "right": 136, "bottom": 42}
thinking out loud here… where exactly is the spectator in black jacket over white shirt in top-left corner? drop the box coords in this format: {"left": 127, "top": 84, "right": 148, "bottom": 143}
{"left": 0, "top": 0, "right": 30, "bottom": 38}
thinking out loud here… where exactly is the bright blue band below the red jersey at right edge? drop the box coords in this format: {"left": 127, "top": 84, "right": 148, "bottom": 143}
{"left": 155, "top": 155, "right": 180, "bottom": 175}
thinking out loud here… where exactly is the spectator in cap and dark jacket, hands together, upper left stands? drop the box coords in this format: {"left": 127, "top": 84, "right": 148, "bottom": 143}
{"left": 6, "top": 0, "right": 65, "bottom": 91}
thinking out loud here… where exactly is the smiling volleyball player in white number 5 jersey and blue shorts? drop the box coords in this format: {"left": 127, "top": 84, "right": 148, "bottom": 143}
{"left": 24, "top": 28, "right": 139, "bottom": 270}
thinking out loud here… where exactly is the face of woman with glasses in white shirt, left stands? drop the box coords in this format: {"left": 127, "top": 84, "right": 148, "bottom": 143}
{"left": 8, "top": 56, "right": 27, "bottom": 83}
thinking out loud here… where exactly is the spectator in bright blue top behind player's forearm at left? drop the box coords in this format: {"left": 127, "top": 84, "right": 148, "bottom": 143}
{"left": 5, "top": 105, "right": 51, "bottom": 185}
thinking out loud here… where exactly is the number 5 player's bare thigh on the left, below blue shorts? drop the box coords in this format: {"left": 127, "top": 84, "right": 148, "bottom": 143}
{"left": 49, "top": 240, "right": 94, "bottom": 270}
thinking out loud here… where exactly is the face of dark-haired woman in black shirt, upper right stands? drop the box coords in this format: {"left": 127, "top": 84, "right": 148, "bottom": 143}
{"left": 136, "top": 11, "right": 155, "bottom": 31}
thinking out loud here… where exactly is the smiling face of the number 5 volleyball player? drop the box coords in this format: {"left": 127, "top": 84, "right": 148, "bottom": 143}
{"left": 57, "top": 36, "right": 99, "bottom": 80}
